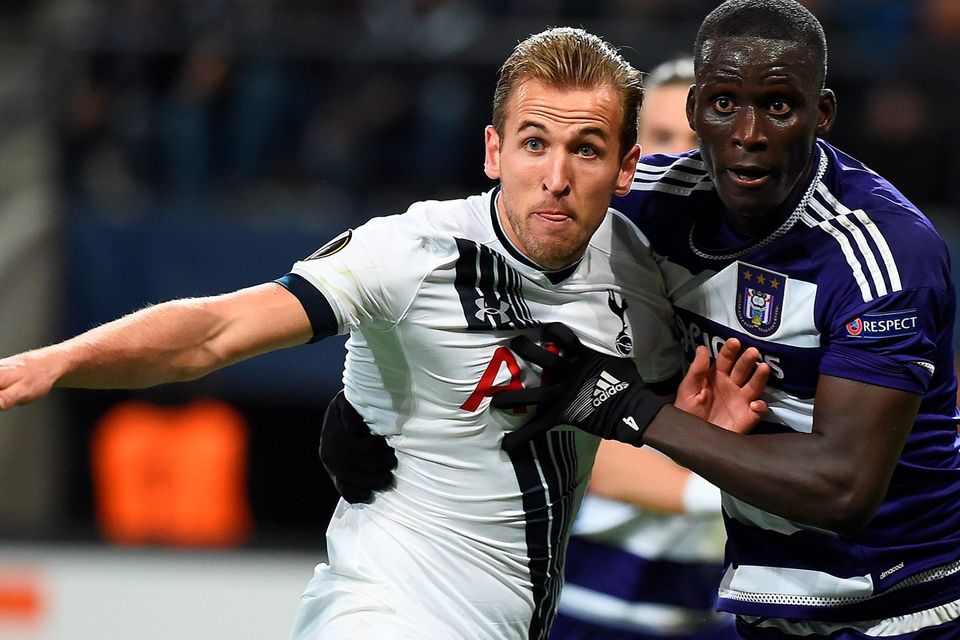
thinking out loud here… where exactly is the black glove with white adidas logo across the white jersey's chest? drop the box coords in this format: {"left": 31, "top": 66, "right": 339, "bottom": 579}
{"left": 490, "top": 323, "right": 668, "bottom": 451}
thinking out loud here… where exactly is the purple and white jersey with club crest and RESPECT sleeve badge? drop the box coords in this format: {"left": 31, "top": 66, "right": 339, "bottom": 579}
{"left": 614, "top": 141, "right": 960, "bottom": 622}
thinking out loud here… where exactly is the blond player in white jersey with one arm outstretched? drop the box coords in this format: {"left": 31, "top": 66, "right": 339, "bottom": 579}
{"left": 0, "top": 28, "right": 768, "bottom": 640}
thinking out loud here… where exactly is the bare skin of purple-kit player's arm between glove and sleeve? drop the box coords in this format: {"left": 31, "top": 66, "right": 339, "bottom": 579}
{"left": 644, "top": 376, "right": 920, "bottom": 535}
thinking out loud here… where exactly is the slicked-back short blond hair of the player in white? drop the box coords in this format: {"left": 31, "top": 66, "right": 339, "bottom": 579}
{"left": 493, "top": 27, "right": 643, "bottom": 155}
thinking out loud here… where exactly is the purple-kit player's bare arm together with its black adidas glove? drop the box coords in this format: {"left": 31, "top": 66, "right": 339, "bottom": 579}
{"left": 492, "top": 320, "right": 921, "bottom": 535}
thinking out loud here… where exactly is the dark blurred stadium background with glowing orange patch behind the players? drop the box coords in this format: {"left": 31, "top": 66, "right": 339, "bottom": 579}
{"left": 0, "top": 0, "right": 960, "bottom": 548}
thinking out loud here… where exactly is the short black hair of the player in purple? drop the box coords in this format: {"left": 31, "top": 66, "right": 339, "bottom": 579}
{"left": 693, "top": 0, "right": 827, "bottom": 86}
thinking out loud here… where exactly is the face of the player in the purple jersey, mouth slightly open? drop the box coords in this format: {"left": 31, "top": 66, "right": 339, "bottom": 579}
{"left": 687, "top": 37, "right": 836, "bottom": 233}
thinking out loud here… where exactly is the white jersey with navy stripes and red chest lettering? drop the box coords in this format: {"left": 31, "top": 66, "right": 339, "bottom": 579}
{"left": 282, "top": 191, "right": 682, "bottom": 640}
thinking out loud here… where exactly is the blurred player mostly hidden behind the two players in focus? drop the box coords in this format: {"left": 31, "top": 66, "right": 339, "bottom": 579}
{"left": 550, "top": 57, "right": 736, "bottom": 640}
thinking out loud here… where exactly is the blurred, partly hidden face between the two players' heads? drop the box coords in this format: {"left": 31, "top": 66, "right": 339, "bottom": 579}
{"left": 638, "top": 84, "right": 697, "bottom": 153}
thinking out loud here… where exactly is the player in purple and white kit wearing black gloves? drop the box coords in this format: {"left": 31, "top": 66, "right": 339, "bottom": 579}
{"left": 325, "top": 0, "right": 960, "bottom": 640}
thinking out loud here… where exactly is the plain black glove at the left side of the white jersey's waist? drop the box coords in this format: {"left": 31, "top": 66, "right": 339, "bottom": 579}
{"left": 320, "top": 391, "right": 397, "bottom": 504}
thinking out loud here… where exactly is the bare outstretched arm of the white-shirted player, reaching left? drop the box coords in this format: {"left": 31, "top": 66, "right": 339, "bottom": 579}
{"left": 0, "top": 283, "right": 312, "bottom": 409}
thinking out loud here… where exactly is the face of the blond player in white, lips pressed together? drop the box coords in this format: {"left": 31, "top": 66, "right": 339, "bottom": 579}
{"left": 484, "top": 79, "right": 639, "bottom": 269}
